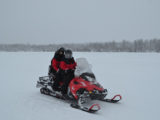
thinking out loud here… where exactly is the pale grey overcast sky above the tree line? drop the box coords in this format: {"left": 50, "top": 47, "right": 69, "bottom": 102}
{"left": 0, "top": 0, "right": 160, "bottom": 44}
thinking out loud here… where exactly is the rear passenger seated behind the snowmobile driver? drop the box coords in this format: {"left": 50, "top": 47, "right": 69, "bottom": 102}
{"left": 48, "top": 47, "right": 65, "bottom": 76}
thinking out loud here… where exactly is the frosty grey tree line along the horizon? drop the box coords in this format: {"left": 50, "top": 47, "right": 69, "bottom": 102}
{"left": 0, "top": 39, "right": 160, "bottom": 52}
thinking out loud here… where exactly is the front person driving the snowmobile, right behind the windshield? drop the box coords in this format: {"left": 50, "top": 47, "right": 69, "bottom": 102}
{"left": 54, "top": 50, "right": 76, "bottom": 94}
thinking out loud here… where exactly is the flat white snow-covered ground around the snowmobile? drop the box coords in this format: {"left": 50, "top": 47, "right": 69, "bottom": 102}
{"left": 0, "top": 52, "right": 160, "bottom": 120}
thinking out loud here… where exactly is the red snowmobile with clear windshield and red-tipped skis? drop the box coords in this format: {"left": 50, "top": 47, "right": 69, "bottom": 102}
{"left": 36, "top": 58, "right": 122, "bottom": 113}
